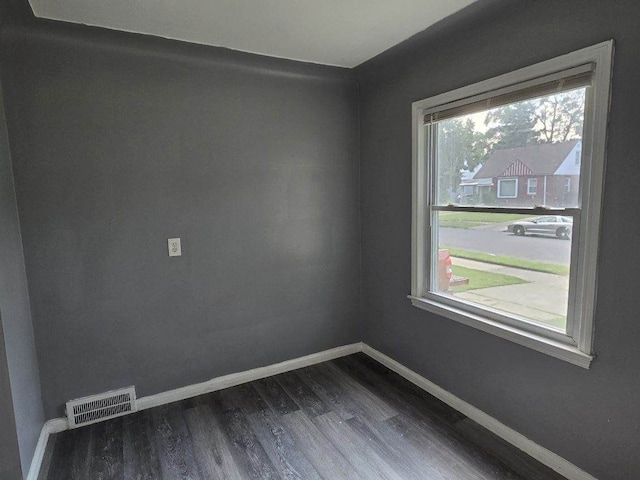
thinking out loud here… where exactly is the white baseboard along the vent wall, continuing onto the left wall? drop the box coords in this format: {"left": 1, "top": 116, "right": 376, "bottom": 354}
{"left": 27, "top": 343, "right": 363, "bottom": 480}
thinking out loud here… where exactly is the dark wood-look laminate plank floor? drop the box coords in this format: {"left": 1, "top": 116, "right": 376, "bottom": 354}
{"left": 39, "top": 354, "right": 563, "bottom": 480}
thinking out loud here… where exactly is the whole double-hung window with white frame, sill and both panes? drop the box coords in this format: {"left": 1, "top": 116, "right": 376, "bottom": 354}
{"left": 409, "top": 42, "right": 613, "bottom": 368}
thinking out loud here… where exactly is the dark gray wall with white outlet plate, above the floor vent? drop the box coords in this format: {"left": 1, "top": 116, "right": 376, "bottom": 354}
{"left": 3, "top": 23, "right": 361, "bottom": 418}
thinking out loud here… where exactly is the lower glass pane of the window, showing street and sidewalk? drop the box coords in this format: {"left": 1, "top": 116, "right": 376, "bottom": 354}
{"left": 431, "top": 212, "right": 573, "bottom": 332}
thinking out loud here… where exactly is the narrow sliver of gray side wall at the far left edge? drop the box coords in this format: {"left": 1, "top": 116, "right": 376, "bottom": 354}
{"left": 0, "top": 70, "right": 44, "bottom": 479}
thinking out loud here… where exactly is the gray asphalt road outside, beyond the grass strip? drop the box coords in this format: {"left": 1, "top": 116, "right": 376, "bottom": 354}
{"left": 440, "top": 227, "right": 571, "bottom": 265}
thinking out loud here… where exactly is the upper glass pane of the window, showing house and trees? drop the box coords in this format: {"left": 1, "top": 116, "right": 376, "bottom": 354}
{"left": 433, "top": 88, "right": 586, "bottom": 207}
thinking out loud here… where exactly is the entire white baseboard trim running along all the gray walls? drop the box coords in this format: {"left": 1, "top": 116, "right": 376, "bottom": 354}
{"left": 27, "top": 343, "right": 597, "bottom": 480}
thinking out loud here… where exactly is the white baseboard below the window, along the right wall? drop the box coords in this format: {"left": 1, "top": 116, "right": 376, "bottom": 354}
{"left": 362, "top": 344, "right": 596, "bottom": 480}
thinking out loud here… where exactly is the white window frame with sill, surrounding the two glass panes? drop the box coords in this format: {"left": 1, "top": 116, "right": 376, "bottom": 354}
{"left": 408, "top": 40, "right": 613, "bottom": 368}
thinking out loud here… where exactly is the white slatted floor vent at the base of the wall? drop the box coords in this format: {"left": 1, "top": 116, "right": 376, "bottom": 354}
{"left": 67, "top": 387, "right": 137, "bottom": 428}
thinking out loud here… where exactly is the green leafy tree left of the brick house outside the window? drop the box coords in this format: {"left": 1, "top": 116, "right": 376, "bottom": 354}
{"left": 438, "top": 118, "right": 486, "bottom": 203}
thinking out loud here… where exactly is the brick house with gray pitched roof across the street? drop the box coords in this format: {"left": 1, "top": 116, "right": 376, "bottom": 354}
{"left": 470, "top": 140, "right": 582, "bottom": 207}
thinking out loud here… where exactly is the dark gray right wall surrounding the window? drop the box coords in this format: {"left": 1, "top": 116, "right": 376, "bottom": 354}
{"left": 356, "top": 0, "right": 640, "bottom": 480}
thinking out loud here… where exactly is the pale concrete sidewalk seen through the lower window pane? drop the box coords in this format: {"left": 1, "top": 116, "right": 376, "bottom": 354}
{"left": 452, "top": 257, "right": 569, "bottom": 328}
